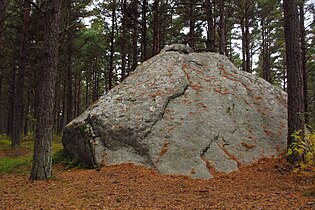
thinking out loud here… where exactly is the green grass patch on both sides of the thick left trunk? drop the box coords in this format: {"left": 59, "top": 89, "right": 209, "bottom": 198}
{"left": 0, "top": 135, "right": 63, "bottom": 174}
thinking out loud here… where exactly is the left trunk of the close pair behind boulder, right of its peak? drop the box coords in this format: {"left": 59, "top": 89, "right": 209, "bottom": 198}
{"left": 205, "top": 0, "right": 216, "bottom": 52}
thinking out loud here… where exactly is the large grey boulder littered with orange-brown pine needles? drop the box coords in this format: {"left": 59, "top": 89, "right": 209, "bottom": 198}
{"left": 62, "top": 44, "right": 287, "bottom": 179}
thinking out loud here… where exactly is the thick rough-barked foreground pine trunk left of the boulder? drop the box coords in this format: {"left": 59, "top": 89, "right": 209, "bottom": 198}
{"left": 30, "top": 0, "right": 60, "bottom": 180}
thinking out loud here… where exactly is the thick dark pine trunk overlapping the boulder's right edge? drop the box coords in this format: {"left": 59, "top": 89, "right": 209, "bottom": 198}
{"left": 283, "top": 0, "right": 304, "bottom": 163}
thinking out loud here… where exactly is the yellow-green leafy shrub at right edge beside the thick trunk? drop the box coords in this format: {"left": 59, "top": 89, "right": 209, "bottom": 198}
{"left": 287, "top": 130, "right": 315, "bottom": 172}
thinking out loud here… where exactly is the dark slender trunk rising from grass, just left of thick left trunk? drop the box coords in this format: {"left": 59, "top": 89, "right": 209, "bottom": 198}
{"left": 11, "top": 1, "right": 31, "bottom": 148}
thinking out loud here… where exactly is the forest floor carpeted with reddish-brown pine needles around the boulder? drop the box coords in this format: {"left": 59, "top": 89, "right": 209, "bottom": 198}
{"left": 0, "top": 139, "right": 315, "bottom": 210}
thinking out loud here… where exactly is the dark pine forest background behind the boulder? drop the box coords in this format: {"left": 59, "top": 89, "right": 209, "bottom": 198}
{"left": 0, "top": 0, "right": 315, "bottom": 139}
